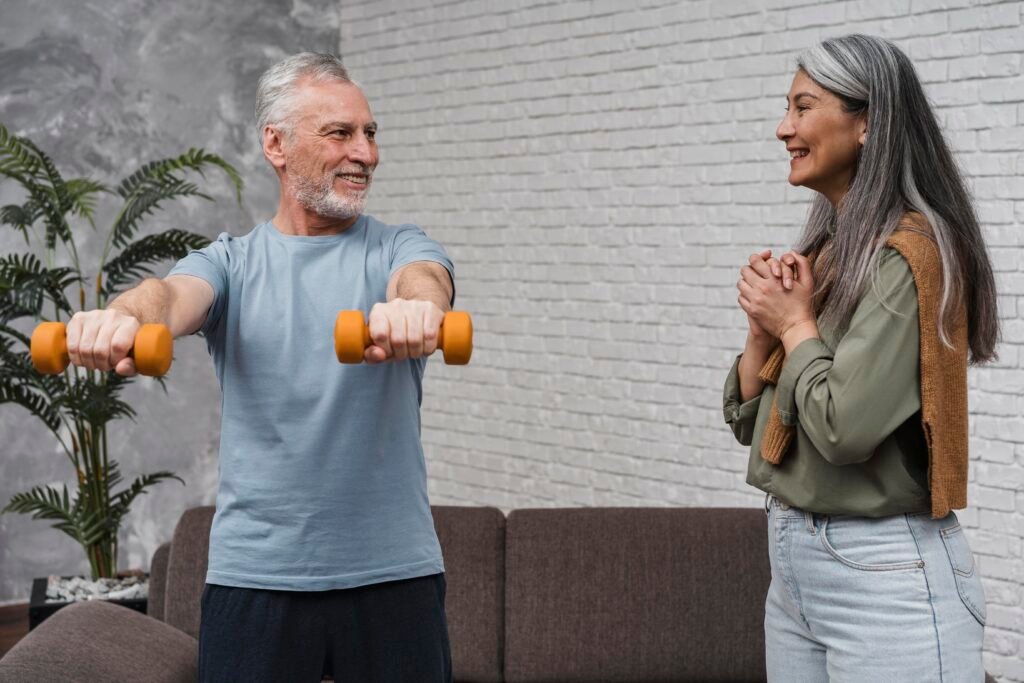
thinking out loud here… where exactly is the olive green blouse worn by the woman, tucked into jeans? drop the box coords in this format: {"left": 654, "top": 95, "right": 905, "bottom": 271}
{"left": 724, "top": 248, "right": 930, "bottom": 517}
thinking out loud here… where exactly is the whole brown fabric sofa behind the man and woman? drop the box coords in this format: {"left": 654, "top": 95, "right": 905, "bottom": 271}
{"left": 0, "top": 507, "right": 991, "bottom": 683}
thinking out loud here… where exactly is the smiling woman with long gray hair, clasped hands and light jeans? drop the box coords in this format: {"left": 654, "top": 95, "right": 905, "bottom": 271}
{"left": 724, "top": 35, "right": 998, "bottom": 683}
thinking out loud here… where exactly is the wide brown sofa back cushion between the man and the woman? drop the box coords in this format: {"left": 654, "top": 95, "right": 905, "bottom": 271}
{"left": 505, "top": 508, "right": 770, "bottom": 683}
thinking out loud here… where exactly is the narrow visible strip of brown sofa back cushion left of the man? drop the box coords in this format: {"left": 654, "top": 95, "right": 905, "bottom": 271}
{"left": 164, "top": 505, "right": 214, "bottom": 638}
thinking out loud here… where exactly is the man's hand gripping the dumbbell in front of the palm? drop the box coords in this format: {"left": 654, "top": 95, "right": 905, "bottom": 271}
{"left": 68, "top": 308, "right": 141, "bottom": 377}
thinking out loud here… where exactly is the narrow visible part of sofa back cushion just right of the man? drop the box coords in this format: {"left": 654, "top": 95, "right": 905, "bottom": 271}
{"left": 432, "top": 506, "right": 505, "bottom": 683}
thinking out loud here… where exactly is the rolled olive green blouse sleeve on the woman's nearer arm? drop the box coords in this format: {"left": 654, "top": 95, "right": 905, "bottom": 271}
{"left": 776, "top": 248, "right": 921, "bottom": 465}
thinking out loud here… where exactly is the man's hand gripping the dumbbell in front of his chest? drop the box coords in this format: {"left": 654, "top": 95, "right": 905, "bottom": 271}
{"left": 362, "top": 299, "right": 444, "bottom": 365}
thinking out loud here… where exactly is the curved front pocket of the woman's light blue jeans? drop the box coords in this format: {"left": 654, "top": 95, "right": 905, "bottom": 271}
{"left": 819, "top": 515, "right": 925, "bottom": 571}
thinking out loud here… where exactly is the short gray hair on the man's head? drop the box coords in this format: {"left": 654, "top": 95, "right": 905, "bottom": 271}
{"left": 256, "top": 52, "right": 353, "bottom": 145}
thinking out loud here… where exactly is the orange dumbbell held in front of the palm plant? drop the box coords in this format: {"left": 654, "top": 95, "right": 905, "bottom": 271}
{"left": 32, "top": 323, "right": 174, "bottom": 377}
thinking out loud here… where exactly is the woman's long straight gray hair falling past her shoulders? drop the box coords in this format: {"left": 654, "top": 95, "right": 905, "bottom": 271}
{"left": 797, "top": 35, "right": 999, "bottom": 364}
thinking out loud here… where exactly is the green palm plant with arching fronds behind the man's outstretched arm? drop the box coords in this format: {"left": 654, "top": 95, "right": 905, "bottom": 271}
{"left": 0, "top": 123, "right": 242, "bottom": 618}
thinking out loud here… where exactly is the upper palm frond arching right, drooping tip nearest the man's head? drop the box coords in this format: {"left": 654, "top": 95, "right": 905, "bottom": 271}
{"left": 113, "top": 148, "right": 243, "bottom": 247}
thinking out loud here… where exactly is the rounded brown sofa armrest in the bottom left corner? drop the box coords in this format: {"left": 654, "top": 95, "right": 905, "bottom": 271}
{"left": 0, "top": 600, "right": 199, "bottom": 683}
